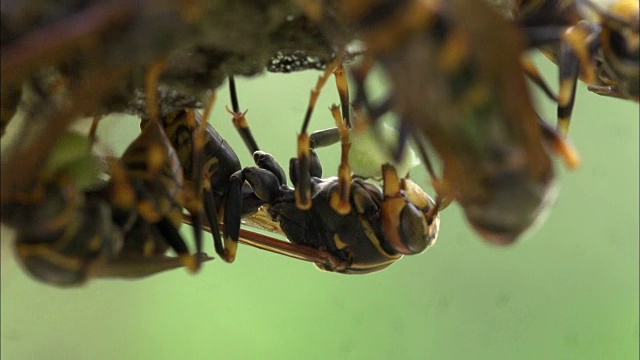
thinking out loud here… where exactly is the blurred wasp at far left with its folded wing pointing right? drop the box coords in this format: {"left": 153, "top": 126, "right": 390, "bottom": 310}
{"left": 2, "top": 128, "right": 210, "bottom": 286}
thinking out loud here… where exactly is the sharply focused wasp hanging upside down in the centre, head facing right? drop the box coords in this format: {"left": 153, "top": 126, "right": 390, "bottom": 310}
{"left": 185, "top": 63, "right": 440, "bottom": 274}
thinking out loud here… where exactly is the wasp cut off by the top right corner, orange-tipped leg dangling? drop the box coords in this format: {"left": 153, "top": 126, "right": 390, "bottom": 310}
{"left": 513, "top": 0, "right": 640, "bottom": 135}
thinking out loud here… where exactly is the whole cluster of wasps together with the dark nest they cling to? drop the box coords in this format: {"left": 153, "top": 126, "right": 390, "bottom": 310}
{"left": 0, "top": 0, "right": 640, "bottom": 286}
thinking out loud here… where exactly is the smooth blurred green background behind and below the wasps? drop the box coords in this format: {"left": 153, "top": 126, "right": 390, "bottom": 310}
{"left": 1, "top": 54, "right": 639, "bottom": 359}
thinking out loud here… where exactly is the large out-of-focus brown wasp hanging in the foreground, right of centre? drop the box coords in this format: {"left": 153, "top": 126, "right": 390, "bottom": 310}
{"left": 298, "top": 0, "right": 577, "bottom": 244}
